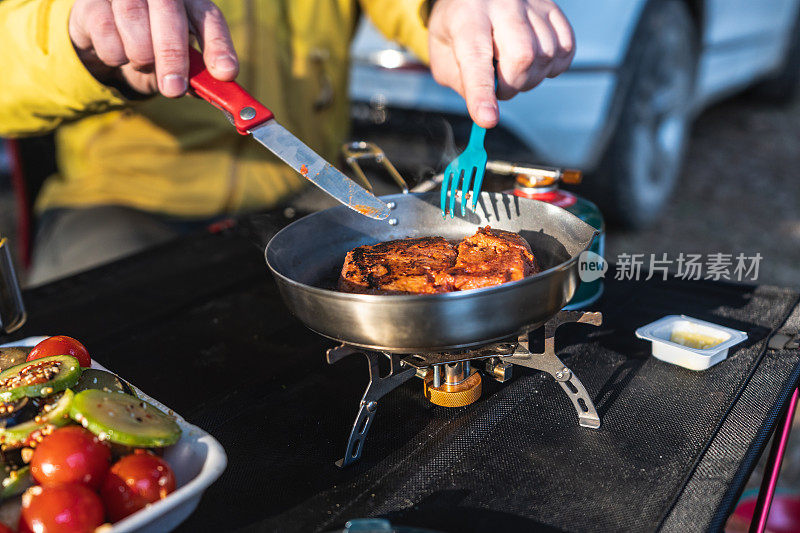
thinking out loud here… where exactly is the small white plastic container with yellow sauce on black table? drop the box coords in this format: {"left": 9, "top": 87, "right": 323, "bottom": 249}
{"left": 636, "top": 315, "right": 747, "bottom": 370}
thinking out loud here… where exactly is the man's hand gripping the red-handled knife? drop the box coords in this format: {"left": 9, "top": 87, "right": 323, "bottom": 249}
{"left": 69, "top": 0, "right": 239, "bottom": 98}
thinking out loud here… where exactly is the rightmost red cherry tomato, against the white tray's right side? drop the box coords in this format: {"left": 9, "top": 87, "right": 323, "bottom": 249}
{"left": 100, "top": 453, "right": 175, "bottom": 522}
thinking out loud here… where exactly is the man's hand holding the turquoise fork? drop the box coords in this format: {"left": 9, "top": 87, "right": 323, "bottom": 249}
{"left": 428, "top": 0, "right": 575, "bottom": 128}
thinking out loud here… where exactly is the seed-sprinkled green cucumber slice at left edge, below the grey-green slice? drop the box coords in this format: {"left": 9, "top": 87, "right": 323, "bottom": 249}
{"left": 0, "top": 355, "right": 81, "bottom": 402}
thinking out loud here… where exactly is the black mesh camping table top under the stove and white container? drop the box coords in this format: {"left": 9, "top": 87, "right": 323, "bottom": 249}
{"left": 6, "top": 215, "right": 800, "bottom": 531}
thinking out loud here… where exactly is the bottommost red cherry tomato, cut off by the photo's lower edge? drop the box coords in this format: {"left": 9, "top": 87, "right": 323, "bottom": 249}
{"left": 20, "top": 483, "right": 104, "bottom": 533}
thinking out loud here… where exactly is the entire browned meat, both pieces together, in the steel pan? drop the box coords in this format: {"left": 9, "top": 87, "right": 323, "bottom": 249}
{"left": 339, "top": 226, "right": 539, "bottom": 294}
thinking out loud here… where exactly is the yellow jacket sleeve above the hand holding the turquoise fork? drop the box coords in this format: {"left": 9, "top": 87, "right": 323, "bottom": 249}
{"left": 361, "top": 0, "right": 430, "bottom": 63}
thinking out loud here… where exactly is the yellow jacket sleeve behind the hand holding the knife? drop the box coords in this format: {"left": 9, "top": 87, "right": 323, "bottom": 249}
{"left": 0, "top": 0, "right": 126, "bottom": 137}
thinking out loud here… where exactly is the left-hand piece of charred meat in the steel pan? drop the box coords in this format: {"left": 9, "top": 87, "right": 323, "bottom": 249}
{"left": 339, "top": 237, "right": 456, "bottom": 294}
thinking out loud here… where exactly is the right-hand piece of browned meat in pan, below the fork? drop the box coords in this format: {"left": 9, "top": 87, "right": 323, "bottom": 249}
{"left": 447, "top": 226, "right": 540, "bottom": 291}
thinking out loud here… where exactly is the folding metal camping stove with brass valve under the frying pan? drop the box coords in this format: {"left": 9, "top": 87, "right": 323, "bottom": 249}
{"left": 327, "top": 311, "right": 603, "bottom": 467}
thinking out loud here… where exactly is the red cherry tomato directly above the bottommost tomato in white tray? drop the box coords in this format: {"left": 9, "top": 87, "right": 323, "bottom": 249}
{"left": 31, "top": 426, "right": 111, "bottom": 489}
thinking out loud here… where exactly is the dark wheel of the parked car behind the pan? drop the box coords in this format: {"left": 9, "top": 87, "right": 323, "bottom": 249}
{"left": 584, "top": 0, "right": 698, "bottom": 228}
